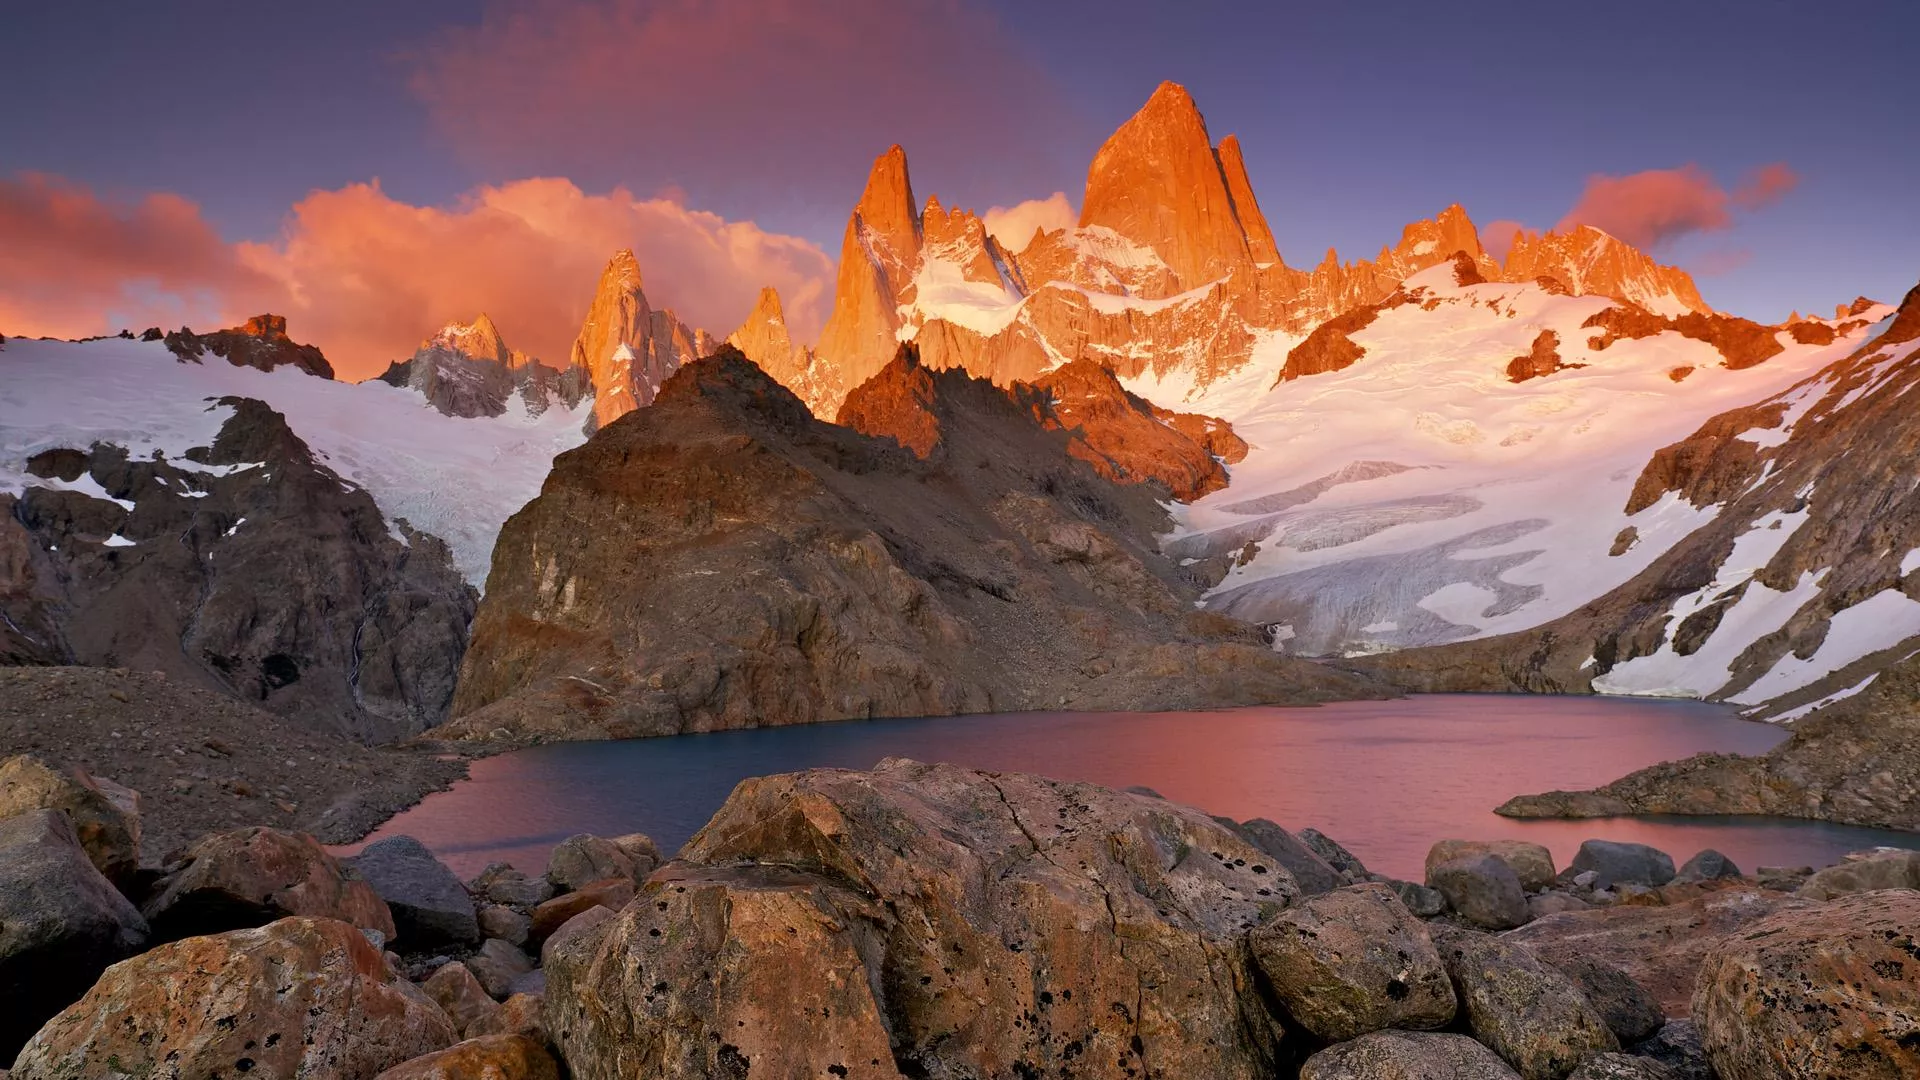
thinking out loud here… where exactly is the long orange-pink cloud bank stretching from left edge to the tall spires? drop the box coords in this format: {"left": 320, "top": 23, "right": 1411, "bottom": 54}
{"left": 0, "top": 175, "right": 833, "bottom": 379}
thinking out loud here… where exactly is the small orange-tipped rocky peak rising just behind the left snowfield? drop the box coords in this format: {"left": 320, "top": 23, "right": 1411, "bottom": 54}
{"left": 380, "top": 311, "right": 593, "bottom": 417}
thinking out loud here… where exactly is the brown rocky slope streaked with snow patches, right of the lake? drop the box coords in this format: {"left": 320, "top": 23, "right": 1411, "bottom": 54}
{"left": 1371, "top": 278, "right": 1920, "bottom": 719}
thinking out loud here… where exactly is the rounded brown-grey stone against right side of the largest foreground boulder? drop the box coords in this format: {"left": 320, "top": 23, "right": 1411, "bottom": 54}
{"left": 1252, "top": 882, "right": 1453, "bottom": 1042}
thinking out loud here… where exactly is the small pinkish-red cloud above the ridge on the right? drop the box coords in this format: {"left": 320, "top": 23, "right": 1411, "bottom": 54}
{"left": 1559, "top": 163, "right": 1797, "bottom": 248}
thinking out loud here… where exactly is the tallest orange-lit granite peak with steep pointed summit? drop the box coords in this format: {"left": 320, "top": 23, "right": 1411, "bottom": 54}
{"left": 1079, "top": 83, "right": 1273, "bottom": 290}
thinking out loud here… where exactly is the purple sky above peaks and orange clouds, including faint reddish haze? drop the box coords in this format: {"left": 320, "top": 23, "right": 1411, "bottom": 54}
{"left": 0, "top": 0, "right": 1920, "bottom": 343}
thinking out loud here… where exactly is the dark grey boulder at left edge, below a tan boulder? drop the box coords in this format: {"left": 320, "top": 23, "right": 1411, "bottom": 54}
{"left": 0, "top": 809, "right": 146, "bottom": 1061}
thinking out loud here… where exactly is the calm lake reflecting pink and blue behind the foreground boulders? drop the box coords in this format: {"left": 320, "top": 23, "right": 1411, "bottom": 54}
{"left": 372, "top": 694, "right": 1920, "bottom": 880}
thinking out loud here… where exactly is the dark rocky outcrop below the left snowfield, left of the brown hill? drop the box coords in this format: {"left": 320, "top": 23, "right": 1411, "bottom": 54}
{"left": 0, "top": 398, "right": 476, "bottom": 742}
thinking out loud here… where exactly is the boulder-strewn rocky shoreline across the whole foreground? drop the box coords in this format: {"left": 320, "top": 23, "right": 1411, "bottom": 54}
{"left": 0, "top": 757, "right": 1920, "bottom": 1080}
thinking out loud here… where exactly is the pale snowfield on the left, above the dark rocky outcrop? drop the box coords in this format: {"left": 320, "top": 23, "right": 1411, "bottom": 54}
{"left": 0, "top": 338, "right": 591, "bottom": 586}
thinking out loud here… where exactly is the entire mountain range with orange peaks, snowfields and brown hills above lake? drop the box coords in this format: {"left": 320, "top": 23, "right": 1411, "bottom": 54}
{"left": 0, "top": 83, "right": 1920, "bottom": 826}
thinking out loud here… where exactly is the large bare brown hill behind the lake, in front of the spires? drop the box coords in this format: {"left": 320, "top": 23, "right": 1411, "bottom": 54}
{"left": 442, "top": 350, "right": 1371, "bottom": 738}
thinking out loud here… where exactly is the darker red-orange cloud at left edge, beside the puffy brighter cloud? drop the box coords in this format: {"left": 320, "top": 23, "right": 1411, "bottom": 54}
{"left": 0, "top": 173, "right": 276, "bottom": 336}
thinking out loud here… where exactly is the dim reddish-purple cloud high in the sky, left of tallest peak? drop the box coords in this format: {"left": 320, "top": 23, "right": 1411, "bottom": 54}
{"left": 411, "top": 0, "right": 1077, "bottom": 219}
